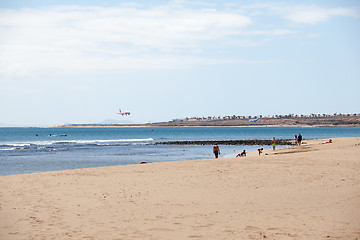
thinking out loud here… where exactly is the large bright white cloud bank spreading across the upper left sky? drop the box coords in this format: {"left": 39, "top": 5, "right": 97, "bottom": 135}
{"left": 0, "top": 5, "right": 251, "bottom": 75}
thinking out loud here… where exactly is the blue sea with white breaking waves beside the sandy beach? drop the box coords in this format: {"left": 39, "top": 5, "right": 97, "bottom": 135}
{"left": 0, "top": 127, "right": 360, "bottom": 175}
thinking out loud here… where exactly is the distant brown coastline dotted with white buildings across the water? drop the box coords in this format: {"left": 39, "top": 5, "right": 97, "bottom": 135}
{"left": 56, "top": 114, "right": 360, "bottom": 127}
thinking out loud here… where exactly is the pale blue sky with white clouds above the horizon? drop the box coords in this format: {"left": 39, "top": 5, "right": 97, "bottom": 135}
{"left": 0, "top": 0, "right": 360, "bottom": 126}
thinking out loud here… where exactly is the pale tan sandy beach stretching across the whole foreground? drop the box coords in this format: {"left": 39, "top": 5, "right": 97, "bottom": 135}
{"left": 0, "top": 138, "right": 360, "bottom": 240}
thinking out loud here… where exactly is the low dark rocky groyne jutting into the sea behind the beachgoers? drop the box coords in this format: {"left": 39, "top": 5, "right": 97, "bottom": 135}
{"left": 155, "top": 139, "right": 294, "bottom": 145}
